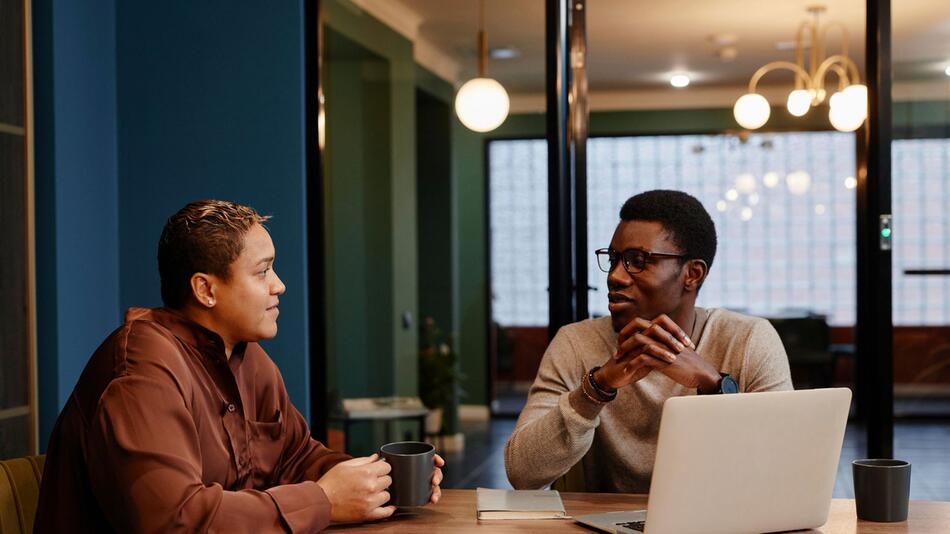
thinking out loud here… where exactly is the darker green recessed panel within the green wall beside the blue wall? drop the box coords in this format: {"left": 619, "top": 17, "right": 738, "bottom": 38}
{"left": 324, "top": 28, "right": 395, "bottom": 397}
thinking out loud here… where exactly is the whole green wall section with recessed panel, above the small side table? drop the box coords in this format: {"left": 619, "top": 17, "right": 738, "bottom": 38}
{"left": 323, "top": 0, "right": 419, "bottom": 454}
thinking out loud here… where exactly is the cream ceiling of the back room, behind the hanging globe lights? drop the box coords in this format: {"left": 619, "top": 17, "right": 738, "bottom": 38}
{"left": 372, "top": 0, "right": 950, "bottom": 94}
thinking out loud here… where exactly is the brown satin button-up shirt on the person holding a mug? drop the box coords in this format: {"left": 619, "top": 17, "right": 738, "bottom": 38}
{"left": 35, "top": 308, "right": 349, "bottom": 532}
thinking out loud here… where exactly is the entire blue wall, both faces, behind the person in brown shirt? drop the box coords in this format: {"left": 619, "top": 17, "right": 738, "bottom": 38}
{"left": 34, "top": 0, "right": 309, "bottom": 449}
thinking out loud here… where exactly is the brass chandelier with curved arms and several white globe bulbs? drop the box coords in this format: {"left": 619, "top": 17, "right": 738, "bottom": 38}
{"left": 732, "top": 6, "right": 868, "bottom": 132}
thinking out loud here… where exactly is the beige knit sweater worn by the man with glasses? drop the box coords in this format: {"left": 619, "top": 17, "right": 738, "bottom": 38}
{"left": 505, "top": 308, "right": 792, "bottom": 493}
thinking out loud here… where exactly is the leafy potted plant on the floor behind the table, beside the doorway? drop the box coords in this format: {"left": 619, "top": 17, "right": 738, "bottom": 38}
{"left": 419, "top": 317, "right": 461, "bottom": 434}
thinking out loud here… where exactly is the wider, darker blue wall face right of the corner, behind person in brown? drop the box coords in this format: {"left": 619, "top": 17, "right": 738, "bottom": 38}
{"left": 116, "top": 0, "right": 309, "bottom": 417}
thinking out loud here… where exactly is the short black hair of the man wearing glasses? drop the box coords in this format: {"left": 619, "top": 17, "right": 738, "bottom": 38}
{"left": 620, "top": 189, "right": 716, "bottom": 268}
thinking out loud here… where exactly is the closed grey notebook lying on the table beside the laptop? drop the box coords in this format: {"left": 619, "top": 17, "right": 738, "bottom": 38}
{"left": 475, "top": 488, "right": 570, "bottom": 519}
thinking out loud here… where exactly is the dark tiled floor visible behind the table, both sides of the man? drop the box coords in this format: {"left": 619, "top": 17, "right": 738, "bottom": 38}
{"left": 443, "top": 418, "right": 950, "bottom": 501}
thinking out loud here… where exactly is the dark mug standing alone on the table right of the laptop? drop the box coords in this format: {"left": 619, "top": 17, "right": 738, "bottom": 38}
{"left": 851, "top": 460, "right": 910, "bottom": 523}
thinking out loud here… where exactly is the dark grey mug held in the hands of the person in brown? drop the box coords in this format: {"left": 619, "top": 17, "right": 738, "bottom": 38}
{"left": 379, "top": 441, "right": 435, "bottom": 507}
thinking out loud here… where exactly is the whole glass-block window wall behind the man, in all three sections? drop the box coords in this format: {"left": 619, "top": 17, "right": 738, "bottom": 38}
{"left": 489, "top": 132, "right": 950, "bottom": 326}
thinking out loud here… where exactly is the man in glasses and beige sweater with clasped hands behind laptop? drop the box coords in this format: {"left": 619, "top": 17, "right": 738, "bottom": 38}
{"left": 505, "top": 191, "right": 792, "bottom": 493}
